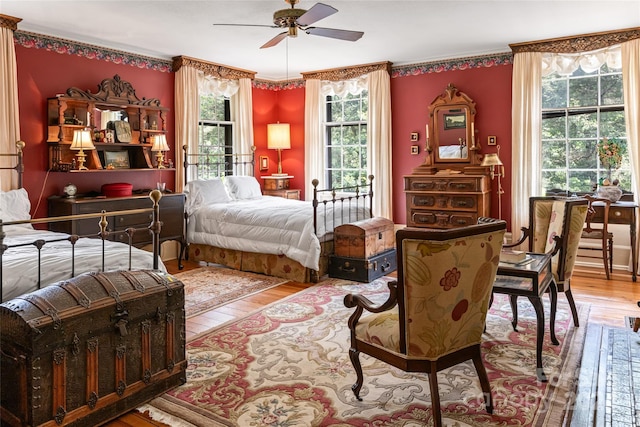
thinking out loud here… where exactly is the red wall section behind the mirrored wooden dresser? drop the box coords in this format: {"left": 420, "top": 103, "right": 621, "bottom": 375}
{"left": 390, "top": 65, "right": 512, "bottom": 224}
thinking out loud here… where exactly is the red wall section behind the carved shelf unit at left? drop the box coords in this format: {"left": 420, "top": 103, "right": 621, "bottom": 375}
{"left": 16, "top": 45, "right": 175, "bottom": 221}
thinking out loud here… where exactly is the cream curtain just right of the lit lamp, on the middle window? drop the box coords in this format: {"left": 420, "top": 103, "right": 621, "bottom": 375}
{"left": 304, "top": 79, "right": 326, "bottom": 200}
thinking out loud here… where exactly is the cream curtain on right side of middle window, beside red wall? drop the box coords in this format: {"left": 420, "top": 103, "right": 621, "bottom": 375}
{"left": 367, "top": 70, "right": 393, "bottom": 219}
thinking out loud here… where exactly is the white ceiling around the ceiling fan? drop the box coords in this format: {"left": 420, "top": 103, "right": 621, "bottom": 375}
{"left": 0, "top": 0, "right": 640, "bottom": 81}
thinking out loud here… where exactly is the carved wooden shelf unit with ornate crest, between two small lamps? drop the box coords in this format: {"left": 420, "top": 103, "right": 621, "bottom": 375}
{"left": 47, "top": 75, "right": 169, "bottom": 172}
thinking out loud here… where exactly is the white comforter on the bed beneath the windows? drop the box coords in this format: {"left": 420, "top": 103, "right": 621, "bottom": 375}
{"left": 187, "top": 196, "right": 369, "bottom": 270}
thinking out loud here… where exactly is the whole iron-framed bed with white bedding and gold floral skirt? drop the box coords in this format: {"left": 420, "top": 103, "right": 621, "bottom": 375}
{"left": 184, "top": 145, "right": 373, "bottom": 282}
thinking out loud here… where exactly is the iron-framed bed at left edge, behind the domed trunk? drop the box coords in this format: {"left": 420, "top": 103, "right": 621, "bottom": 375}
{"left": 0, "top": 142, "right": 166, "bottom": 301}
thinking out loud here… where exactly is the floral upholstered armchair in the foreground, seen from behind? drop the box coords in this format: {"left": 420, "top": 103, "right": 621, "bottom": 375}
{"left": 344, "top": 221, "right": 506, "bottom": 426}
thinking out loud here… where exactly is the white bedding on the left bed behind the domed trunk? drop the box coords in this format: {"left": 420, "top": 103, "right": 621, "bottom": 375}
{"left": 2, "top": 226, "right": 166, "bottom": 301}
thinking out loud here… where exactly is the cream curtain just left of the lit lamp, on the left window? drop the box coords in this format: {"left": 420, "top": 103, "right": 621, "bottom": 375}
{"left": 231, "top": 78, "right": 253, "bottom": 174}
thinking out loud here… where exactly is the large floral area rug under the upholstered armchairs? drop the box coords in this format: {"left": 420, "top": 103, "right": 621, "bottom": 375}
{"left": 144, "top": 279, "right": 589, "bottom": 427}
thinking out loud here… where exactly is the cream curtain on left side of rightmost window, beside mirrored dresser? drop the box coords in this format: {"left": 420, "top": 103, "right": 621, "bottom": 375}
{"left": 511, "top": 52, "right": 542, "bottom": 240}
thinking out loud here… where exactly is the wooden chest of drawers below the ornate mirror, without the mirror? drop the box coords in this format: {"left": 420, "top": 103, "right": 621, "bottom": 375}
{"left": 404, "top": 172, "right": 491, "bottom": 228}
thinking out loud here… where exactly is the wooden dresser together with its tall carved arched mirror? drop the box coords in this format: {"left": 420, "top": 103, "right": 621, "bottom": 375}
{"left": 404, "top": 84, "right": 491, "bottom": 228}
